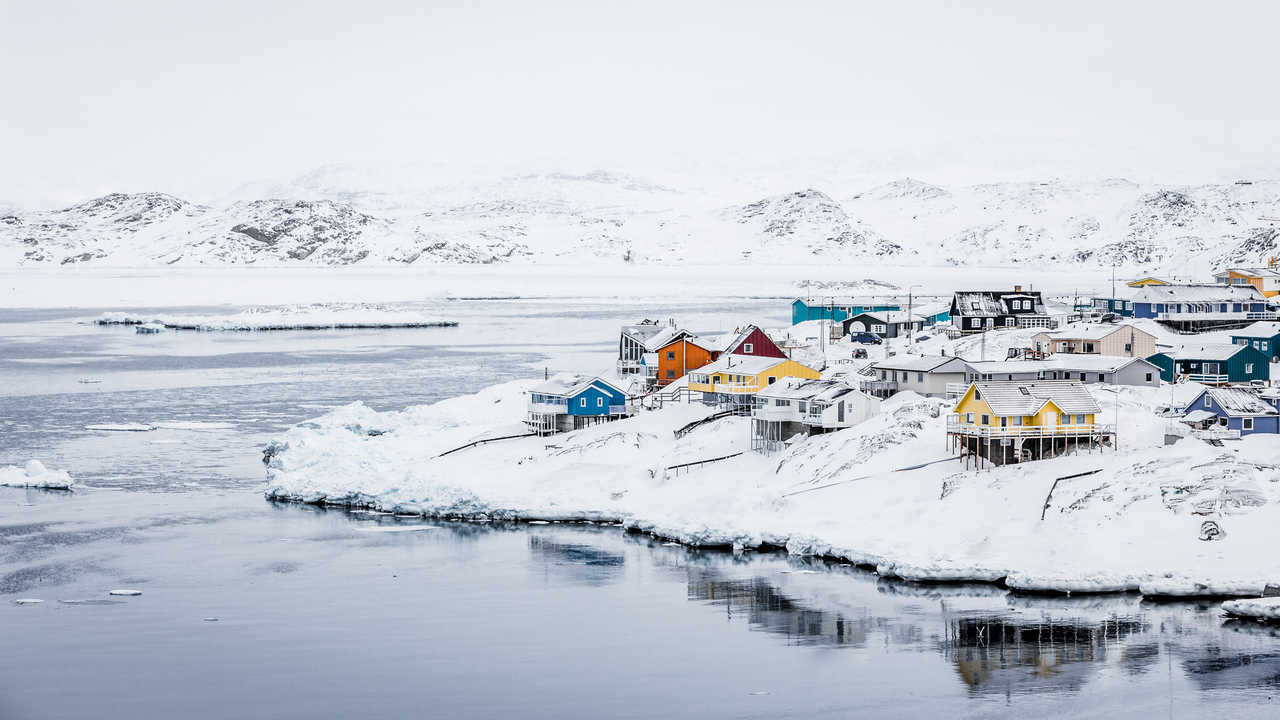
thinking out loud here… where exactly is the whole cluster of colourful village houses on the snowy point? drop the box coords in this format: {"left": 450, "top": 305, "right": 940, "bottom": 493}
{"left": 525, "top": 264, "right": 1280, "bottom": 469}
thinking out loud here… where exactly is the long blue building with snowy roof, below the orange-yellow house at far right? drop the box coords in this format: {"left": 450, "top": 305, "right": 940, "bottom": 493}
{"left": 1132, "top": 284, "right": 1276, "bottom": 332}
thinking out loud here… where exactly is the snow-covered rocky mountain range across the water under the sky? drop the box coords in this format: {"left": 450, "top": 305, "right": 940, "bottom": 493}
{"left": 0, "top": 169, "right": 1280, "bottom": 271}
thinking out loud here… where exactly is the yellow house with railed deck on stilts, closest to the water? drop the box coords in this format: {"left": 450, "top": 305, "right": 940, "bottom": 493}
{"left": 947, "top": 380, "right": 1115, "bottom": 465}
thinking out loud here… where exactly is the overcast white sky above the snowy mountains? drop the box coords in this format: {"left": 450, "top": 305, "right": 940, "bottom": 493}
{"left": 0, "top": 0, "right": 1280, "bottom": 205}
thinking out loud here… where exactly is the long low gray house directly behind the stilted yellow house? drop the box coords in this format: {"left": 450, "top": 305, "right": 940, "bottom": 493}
{"left": 964, "top": 354, "right": 1160, "bottom": 387}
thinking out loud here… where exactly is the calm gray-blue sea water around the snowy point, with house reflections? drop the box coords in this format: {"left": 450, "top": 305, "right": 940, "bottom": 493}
{"left": 0, "top": 301, "right": 1280, "bottom": 720}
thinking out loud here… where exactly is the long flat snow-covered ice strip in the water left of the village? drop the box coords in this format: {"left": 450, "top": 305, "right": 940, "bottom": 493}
{"left": 93, "top": 304, "right": 457, "bottom": 332}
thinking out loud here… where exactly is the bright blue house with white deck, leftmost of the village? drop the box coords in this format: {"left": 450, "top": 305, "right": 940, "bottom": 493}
{"left": 525, "top": 373, "right": 635, "bottom": 434}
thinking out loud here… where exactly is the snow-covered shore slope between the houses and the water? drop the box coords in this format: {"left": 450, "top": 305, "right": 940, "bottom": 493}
{"left": 266, "top": 380, "right": 1280, "bottom": 596}
